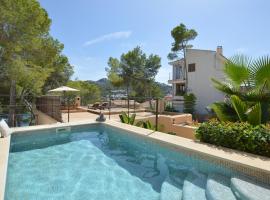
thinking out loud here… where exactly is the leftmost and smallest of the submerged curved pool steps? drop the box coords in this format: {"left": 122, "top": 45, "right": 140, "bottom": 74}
{"left": 160, "top": 176, "right": 182, "bottom": 200}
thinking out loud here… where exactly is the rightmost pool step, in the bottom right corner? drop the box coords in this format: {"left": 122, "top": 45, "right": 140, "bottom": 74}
{"left": 231, "top": 177, "right": 270, "bottom": 200}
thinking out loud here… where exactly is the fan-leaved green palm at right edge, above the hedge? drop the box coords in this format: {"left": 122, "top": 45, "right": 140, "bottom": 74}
{"left": 212, "top": 55, "right": 270, "bottom": 123}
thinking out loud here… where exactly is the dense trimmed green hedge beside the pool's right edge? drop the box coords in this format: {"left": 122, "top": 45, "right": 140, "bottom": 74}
{"left": 196, "top": 120, "right": 270, "bottom": 157}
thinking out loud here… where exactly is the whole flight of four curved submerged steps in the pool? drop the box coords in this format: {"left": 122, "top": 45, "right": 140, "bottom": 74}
{"left": 160, "top": 171, "right": 270, "bottom": 200}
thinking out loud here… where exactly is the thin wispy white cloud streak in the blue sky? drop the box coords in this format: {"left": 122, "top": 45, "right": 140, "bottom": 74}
{"left": 84, "top": 31, "right": 132, "bottom": 46}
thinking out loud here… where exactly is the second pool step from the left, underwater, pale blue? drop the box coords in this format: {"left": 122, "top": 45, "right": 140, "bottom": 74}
{"left": 182, "top": 172, "right": 207, "bottom": 200}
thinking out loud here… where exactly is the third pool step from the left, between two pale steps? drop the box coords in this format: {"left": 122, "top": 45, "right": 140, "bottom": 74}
{"left": 205, "top": 174, "right": 236, "bottom": 200}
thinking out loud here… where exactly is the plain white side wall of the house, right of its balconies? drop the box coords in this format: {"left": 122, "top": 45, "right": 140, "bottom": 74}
{"left": 186, "top": 49, "right": 225, "bottom": 114}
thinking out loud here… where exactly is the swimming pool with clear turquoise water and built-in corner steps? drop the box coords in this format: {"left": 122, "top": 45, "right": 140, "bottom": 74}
{"left": 5, "top": 124, "right": 270, "bottom": 200}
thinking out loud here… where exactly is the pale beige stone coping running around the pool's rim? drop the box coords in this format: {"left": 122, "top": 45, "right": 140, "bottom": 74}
{"left": 0, "top": 120, "right": 270, "bottom": 200}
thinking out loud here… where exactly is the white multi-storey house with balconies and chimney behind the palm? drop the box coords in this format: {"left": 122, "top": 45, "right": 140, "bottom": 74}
{"left": 168, "top": 46, "right": 226, "bottom": 114}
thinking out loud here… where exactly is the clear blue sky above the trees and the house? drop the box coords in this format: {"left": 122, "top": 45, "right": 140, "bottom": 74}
{"left": 40, "top": 0, "right": 270, "bottom": 83}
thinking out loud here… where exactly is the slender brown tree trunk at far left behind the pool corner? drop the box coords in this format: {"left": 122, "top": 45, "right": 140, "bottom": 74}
{"left": 8, "top": 80, "right": 16, "bottom": 127}
